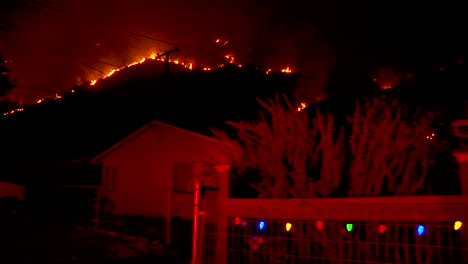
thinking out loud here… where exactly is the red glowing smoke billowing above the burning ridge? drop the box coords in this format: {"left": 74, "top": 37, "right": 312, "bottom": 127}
{"left": 0, "top": 0, "right": 333, "bottom": 104}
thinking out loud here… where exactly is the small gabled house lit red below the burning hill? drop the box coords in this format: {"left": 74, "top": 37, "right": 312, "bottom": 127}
{"left": 91, "top": 121, "right": 228, "bottom": 219}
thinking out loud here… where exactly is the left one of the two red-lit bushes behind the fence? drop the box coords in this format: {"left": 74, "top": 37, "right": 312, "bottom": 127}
{"left": 213, "top": 96, "right": 344, "bottom": 198}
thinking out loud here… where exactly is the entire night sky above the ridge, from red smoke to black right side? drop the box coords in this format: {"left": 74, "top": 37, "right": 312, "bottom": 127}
{"left": 0, "top": 0, "right": 466, "bottom": 105}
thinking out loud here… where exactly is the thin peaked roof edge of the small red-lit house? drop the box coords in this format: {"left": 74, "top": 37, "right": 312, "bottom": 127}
{"left": 90, "top": 120, "right": 226, "bottom": 164}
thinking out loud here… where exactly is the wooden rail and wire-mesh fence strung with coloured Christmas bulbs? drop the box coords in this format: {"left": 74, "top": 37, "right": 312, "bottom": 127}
{"left": 196, "top": 169, "right": 468, "bottom": 264}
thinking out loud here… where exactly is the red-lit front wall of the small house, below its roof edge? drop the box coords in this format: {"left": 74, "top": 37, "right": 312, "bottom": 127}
{"left": 102, "top": 125, "right": 227, "bottom": 218}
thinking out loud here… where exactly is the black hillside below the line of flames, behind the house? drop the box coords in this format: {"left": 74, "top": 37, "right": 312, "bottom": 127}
{"left": 0, "top": 61, "right": 296, "bottom": 183}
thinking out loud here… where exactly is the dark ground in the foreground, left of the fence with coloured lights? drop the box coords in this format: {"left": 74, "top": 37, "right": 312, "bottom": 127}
{"left": 0, "top": 216, "right": 191, "bottom": 264}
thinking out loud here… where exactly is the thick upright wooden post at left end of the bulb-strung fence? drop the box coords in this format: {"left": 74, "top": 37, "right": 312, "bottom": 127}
{"left": 214, "top": 165, "right": 230, "bottom": 264}
